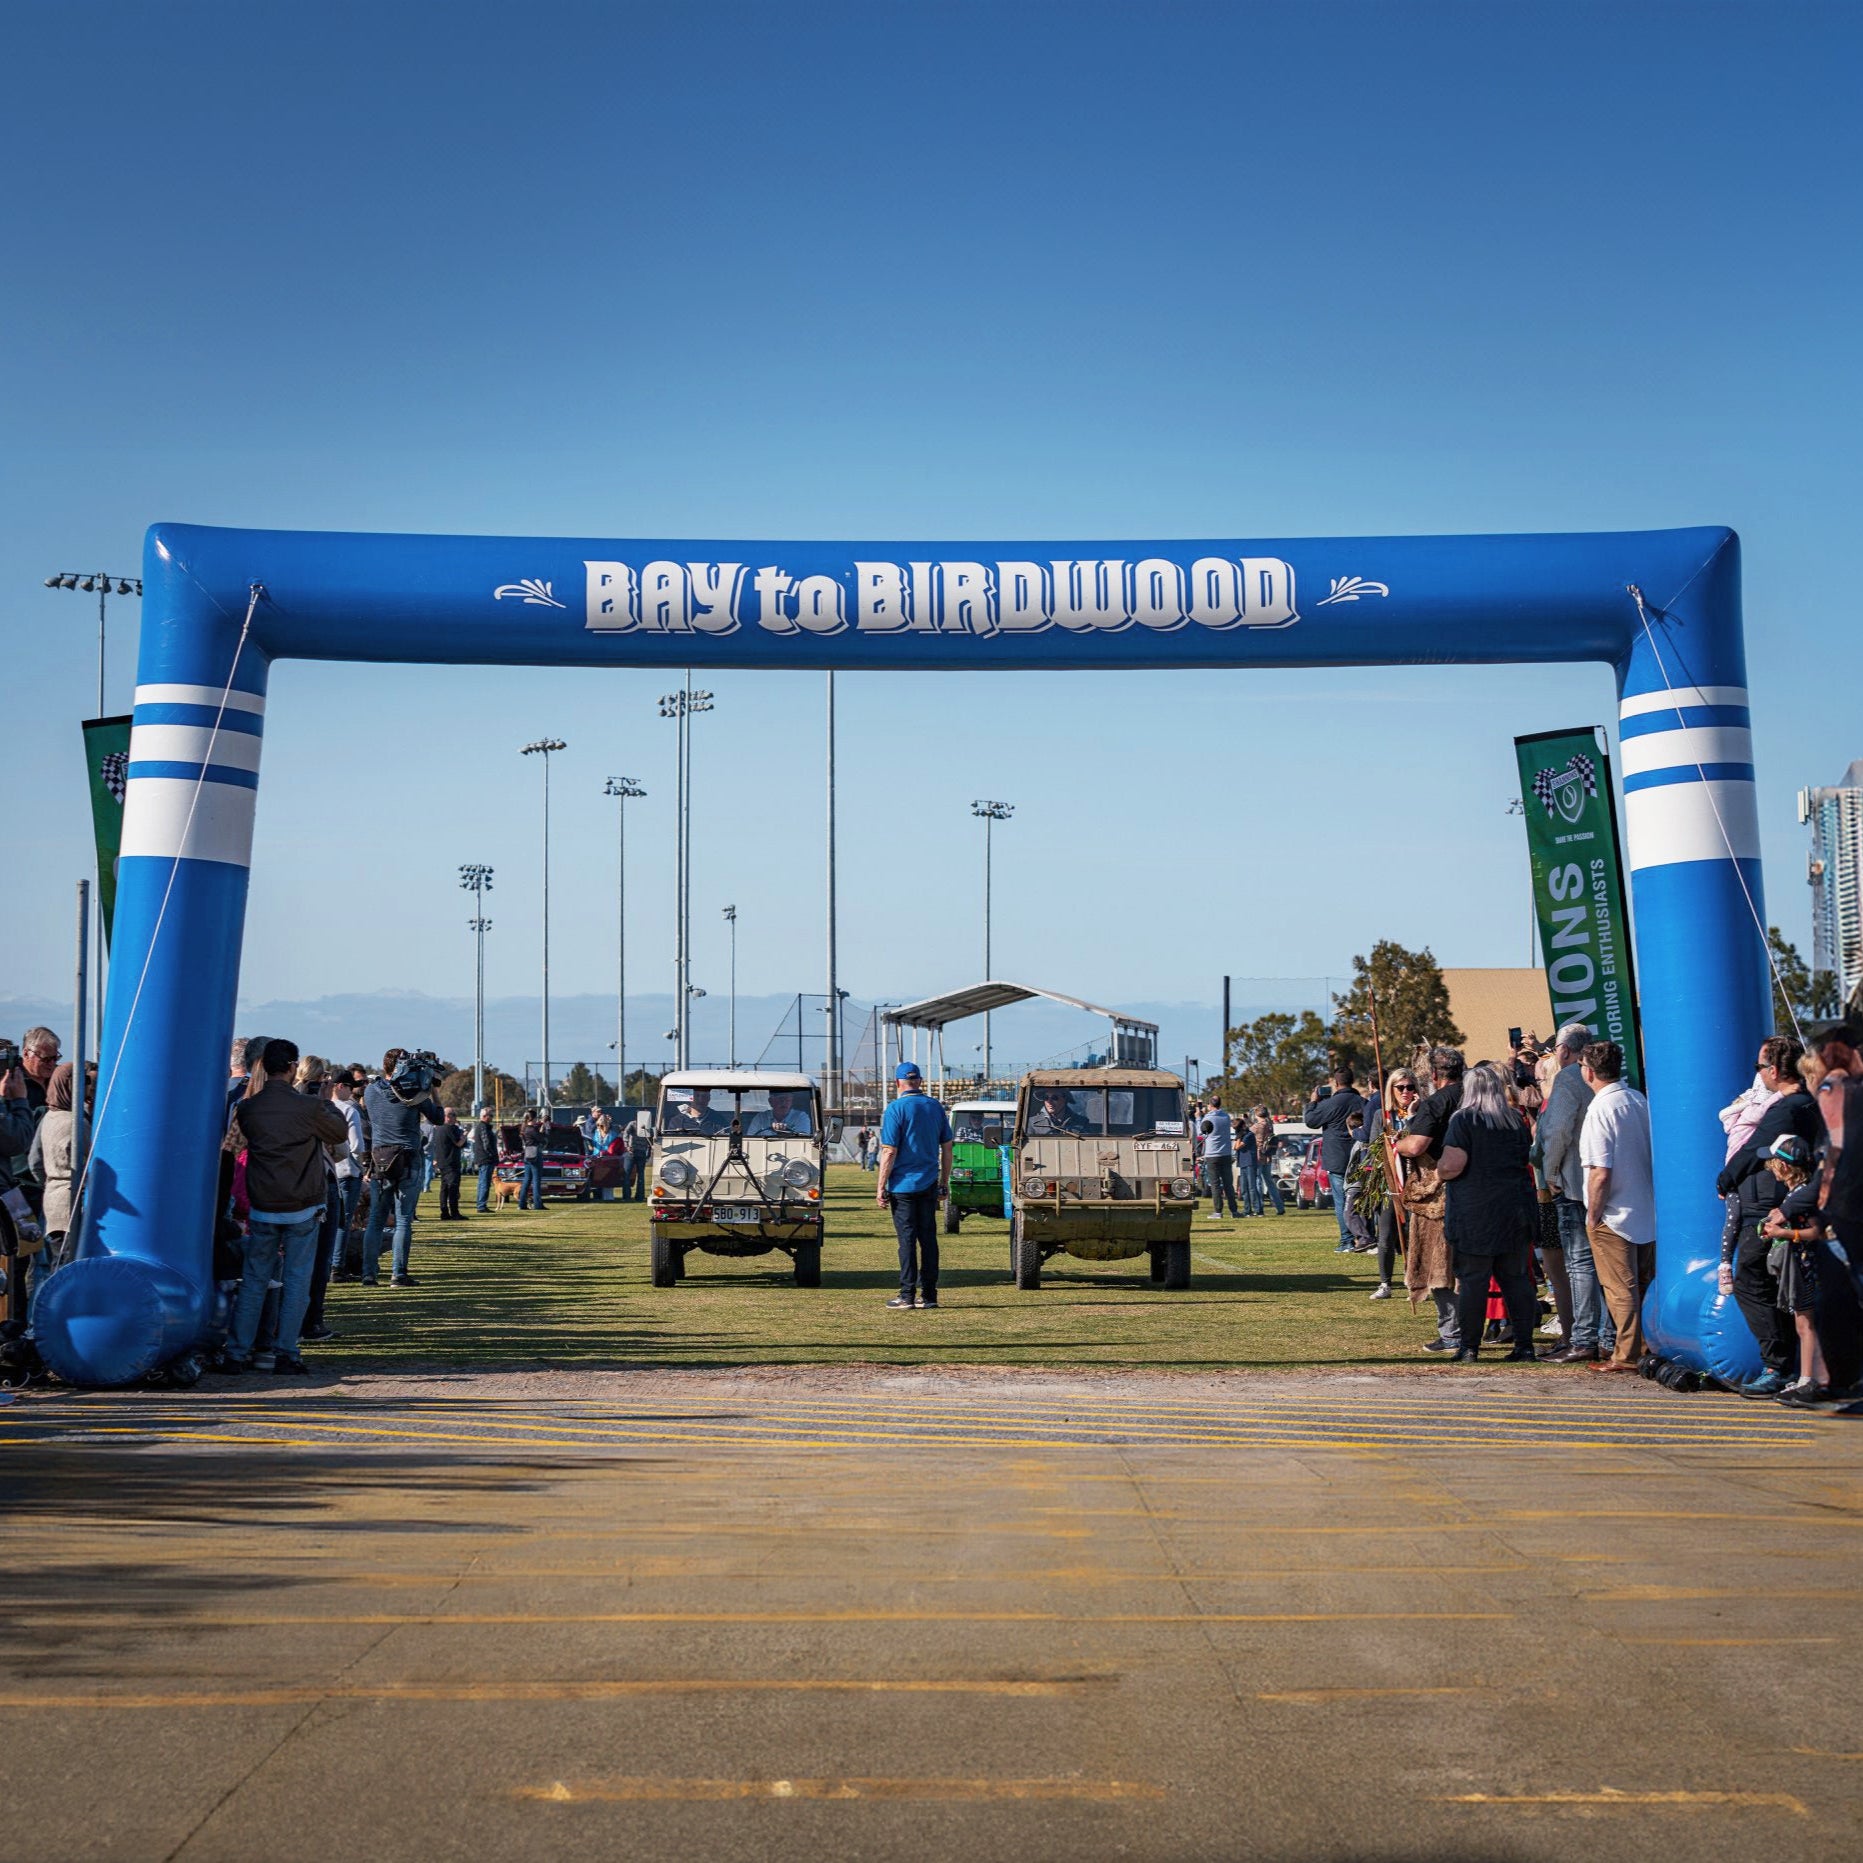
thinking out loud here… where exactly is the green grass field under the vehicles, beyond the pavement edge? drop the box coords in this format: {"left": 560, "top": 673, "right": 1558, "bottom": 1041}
{"left": 313, "top": 1166, "right": 1528, "bottom": 1371}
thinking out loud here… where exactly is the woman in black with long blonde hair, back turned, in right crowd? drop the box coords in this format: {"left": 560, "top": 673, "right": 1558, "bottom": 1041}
{"left": 1438, "top": 1062, "right": 1539, "bottom": 1364}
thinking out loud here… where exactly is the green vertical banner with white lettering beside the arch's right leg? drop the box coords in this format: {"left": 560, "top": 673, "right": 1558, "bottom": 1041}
{"left": 1515, "top": 725, "right": 1643, "bottom": 1086}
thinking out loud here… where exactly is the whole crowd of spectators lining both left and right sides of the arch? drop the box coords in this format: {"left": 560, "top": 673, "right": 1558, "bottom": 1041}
{"left": 0, "top": 1023, "right": 1863, "bottom": 1408}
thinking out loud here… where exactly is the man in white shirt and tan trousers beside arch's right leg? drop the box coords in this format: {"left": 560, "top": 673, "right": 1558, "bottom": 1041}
{"left": 1578, "top": 1041, "right": 1656, "bottom": 1371}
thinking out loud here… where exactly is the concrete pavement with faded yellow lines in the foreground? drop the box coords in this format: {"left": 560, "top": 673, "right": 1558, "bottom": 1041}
{"left": 0, "top": 1367, "right": 1863, "bottom": 1863}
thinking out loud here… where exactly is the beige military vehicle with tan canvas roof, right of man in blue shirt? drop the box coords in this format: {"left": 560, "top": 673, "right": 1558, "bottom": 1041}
{"left": 1010, "top": 1067, "right": 1196, "bottom": 1287}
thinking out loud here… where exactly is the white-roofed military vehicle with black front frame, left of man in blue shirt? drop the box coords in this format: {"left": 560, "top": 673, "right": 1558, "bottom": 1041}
{"left": 648, "top": 1069, "right": 838, "bottom": 1287}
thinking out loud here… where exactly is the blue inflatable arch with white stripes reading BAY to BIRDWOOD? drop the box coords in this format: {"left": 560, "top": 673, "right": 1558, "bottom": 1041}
{"left": 34, "top": 524, "right": 1770, "bottom": 1384}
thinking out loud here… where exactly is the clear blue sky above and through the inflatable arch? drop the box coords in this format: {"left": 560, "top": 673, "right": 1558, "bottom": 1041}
{"left": 0, "top": 0, "right": 1863, "bottom": 1035}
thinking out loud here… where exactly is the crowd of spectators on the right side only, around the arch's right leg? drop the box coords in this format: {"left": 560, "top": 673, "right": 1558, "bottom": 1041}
{"left": 1192, "top": 1023, "right": 1863, "bottom": 1408}
